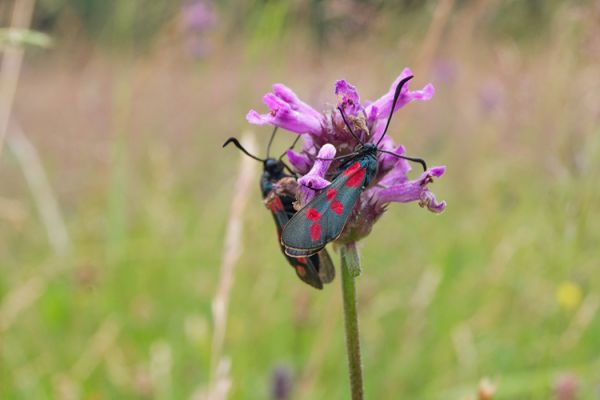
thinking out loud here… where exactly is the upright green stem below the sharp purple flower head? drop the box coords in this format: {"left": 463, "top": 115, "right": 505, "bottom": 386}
{"left": 340, "top": 243, "right": 364, "bottom": 400}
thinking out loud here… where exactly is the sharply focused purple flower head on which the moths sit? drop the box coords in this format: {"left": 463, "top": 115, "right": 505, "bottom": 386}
{"left": 246, "top": 68, "right": 446, "bottom": 241}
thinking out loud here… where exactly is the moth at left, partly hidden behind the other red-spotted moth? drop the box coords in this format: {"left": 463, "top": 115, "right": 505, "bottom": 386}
{"left": 223, "top": 128, "right": 335, "bottom": 289}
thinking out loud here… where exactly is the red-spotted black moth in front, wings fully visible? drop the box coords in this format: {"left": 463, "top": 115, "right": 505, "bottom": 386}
{"left": 281, "top": 76, "right": 427, "bottom": 257}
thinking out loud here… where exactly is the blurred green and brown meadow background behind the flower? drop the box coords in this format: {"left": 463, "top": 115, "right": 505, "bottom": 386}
{"left": 0, "top": 0, "right": 600, "bottom": 400}
